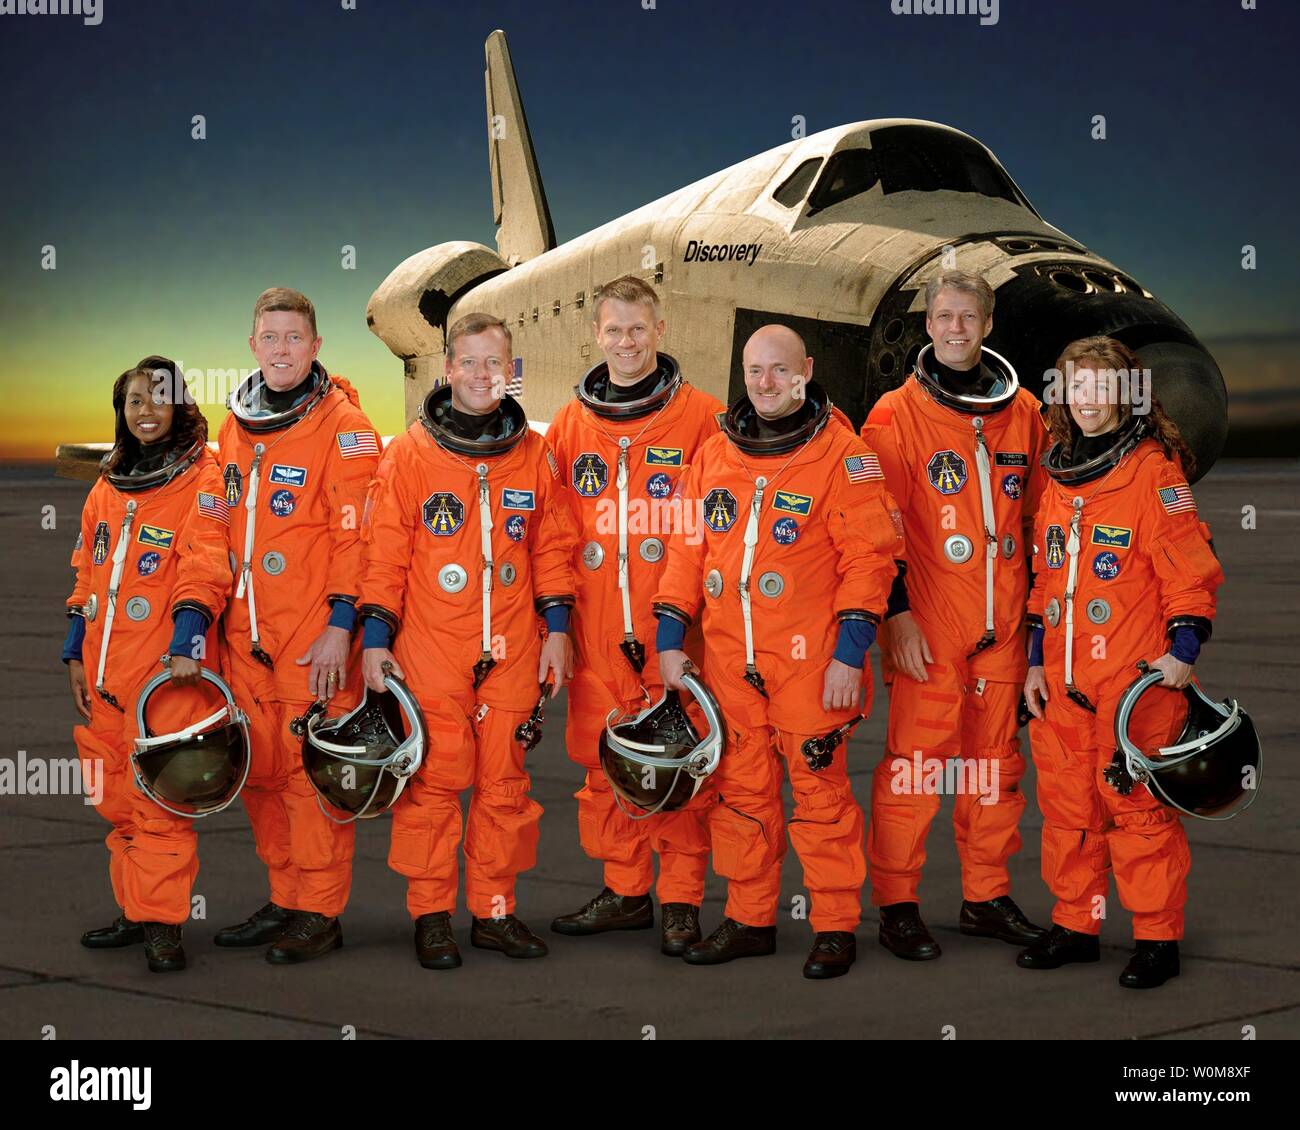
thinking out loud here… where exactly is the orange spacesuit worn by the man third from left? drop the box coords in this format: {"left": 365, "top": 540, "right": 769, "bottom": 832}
{"left": 361, "top": 397, "right": 576, "bottom": 918}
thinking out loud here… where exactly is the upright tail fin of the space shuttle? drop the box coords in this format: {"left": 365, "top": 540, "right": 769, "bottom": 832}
{"left": 484, "top": 31, "right": 555, "bottom": 267}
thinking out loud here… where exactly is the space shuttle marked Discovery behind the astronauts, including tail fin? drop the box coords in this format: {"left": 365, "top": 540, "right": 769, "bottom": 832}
{"left": 367, "top": 31, "right": 1227, "bottom": 476}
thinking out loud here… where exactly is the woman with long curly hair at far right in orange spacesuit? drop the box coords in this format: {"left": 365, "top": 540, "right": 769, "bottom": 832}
{"left": 1017, "top": 337, "right": 1223, "bottom": 988}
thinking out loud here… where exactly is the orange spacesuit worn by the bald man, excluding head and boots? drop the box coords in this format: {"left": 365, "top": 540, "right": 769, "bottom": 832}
{"left": 655, "top": 397, "right": 902, "bottom": 932}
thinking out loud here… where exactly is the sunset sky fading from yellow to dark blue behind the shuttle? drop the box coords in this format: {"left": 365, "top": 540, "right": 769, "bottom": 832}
{"left": 0, "top": 0, "right": 1300, "bottom": 459}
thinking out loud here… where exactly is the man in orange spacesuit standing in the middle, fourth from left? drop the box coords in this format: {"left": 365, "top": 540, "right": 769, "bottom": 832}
{"left": 546, "top": 274, "right": 723, "bottom": 956}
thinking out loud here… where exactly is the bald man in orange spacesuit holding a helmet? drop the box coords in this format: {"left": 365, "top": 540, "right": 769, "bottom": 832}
{"left": 654, "top": 325, "right": 902, "bottom": 979}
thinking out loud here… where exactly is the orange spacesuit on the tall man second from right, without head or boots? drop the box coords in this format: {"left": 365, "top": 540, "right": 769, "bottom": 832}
{"left": 862, "top": 374, "right": 1047, "bottom": 906}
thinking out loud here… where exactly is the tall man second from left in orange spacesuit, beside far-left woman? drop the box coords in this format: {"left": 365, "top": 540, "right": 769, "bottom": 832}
{"left": 215, "top": 287, "right": 380, "bottom": 964}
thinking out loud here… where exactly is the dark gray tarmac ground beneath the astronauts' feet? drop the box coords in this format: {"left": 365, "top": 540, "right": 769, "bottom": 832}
{"left": 0, "top": 462, "right": 1300, "bottom": 1040}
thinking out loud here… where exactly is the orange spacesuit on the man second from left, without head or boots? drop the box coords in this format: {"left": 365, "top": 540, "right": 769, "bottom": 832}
{"left": 217, "top": 367, "right": 380, "bottom": 918}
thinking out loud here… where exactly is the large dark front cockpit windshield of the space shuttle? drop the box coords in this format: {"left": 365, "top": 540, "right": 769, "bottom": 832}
{"left": 809, "top": 126, "right": 1034, "bottom": 215}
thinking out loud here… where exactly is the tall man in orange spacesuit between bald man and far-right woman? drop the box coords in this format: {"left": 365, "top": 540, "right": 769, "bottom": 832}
{"left": 862, "top": 270, "right": 1047, "bottom": 961}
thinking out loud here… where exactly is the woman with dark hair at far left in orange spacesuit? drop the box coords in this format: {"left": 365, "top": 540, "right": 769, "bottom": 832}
{"left": 62, "top": 356, "right": 230, "bottom": 973}
